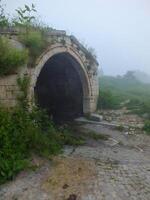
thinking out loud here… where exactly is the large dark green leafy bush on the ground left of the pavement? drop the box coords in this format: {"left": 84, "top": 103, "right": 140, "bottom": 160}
{"left": 0, "top": 108, "right": 62, "bottom": 183}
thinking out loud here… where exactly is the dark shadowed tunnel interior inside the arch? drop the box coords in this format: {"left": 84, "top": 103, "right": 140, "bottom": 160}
{"left": 35, "top": 53, "right": 83, "bottom": 122}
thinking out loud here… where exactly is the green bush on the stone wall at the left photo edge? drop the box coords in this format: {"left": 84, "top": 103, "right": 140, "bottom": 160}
{"left": 0, "top": 37, "right": 28, "bottom": 75}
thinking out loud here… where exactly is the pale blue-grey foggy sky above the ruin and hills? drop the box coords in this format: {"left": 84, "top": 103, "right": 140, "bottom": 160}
{"left": 3, "top": 0, "right": 150, "bottom": 75}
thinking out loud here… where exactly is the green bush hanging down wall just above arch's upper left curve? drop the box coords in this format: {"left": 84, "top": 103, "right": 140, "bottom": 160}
{"left": 20, "top": 31, "right": 46, "bottom": 67}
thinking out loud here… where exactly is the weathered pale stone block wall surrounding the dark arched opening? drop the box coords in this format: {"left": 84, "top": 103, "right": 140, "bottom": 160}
{"left": 0, "top": 30, "right": 98, "bottom": 113}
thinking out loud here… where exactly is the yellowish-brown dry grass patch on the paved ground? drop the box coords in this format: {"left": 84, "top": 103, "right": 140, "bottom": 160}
{"left": 43, "top": 157, "right": 96, "bottom": 200}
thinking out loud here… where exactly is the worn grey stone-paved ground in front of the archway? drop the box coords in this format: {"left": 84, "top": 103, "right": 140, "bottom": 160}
{"left": 0, "top": 125, "right": 150, "bottom": 200}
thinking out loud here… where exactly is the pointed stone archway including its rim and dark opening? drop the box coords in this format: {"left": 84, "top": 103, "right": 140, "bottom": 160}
{"left": 29, "top": 46, "right": 92, "bottom": 118}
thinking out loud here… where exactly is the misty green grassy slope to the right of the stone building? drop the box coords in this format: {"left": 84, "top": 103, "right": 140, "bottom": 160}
{"left": 98, "top": 76, "right": 150, "bottom": 118}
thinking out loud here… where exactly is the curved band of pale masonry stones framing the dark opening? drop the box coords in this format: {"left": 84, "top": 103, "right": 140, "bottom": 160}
{"left": 29, "top": 45, "right": 92, "bottom": 109}
